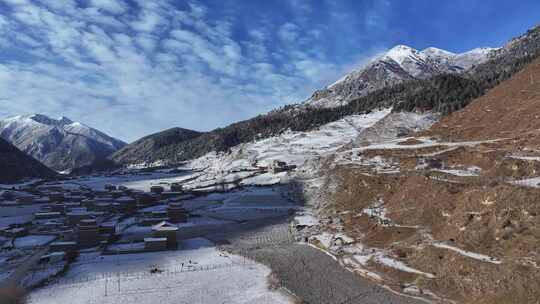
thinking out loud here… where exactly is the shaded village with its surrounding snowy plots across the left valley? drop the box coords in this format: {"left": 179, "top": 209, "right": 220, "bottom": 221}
{"left": 0, "top": 162, "right": 299, "bottom": 300}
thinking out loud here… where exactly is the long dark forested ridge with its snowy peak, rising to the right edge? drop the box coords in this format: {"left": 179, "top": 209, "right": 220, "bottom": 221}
{"left": 107, "top": 27, "right": 540, "bottom": 166}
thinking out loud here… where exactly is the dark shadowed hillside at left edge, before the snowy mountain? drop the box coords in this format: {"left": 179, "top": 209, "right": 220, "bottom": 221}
{"left": 0, "top": 138, "right": 56, "bottom": 183}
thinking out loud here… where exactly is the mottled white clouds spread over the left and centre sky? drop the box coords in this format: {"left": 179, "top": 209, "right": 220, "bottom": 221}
{"left": 0, "top": 0, "right": 378, "bottom": 141}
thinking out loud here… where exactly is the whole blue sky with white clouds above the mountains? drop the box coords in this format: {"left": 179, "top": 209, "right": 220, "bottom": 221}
{"left": 0, "top": 0, "right": 540, "bottom": 141}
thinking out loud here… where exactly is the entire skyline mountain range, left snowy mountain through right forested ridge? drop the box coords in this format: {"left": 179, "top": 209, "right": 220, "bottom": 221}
{"left": 4, "top": 27, "right": 540, "bottom": 179}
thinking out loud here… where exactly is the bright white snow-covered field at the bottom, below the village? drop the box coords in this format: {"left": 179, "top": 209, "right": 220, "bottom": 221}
{"left": 28, "top": 238, "right": 290, "bottom": 304}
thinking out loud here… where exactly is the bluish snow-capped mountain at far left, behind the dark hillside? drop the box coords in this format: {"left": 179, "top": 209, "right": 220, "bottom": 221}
{"left": 0, "top": 114, "right": 126, "bottom": 171}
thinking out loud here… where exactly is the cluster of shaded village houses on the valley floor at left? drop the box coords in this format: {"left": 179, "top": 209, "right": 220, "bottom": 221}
{"left": 0, "top": 180, "right": 192, "bottom": 260}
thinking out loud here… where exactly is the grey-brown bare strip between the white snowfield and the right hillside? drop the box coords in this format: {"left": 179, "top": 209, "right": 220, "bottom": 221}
{"left": 214, "top": 223, "right": 425, "bottom": 304}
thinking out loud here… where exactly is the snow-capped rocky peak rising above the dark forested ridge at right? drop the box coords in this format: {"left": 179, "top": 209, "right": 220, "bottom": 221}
{"left": 304, "top": 45, "right": 495, "bottom": 108}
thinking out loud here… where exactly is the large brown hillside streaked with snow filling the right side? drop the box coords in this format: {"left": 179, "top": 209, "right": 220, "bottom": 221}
{"left": 303, "top": 47, "right": 540, "bottom": 303}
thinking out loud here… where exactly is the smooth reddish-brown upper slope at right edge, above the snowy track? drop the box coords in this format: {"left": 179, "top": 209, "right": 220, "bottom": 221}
{"left": 428, "top": 59, "right": 540, "bottom": 139}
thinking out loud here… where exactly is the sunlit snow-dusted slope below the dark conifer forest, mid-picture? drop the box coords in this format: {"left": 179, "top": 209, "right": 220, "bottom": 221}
{"left": 163, "top": 108, "right": 438, "bottom": 191}
